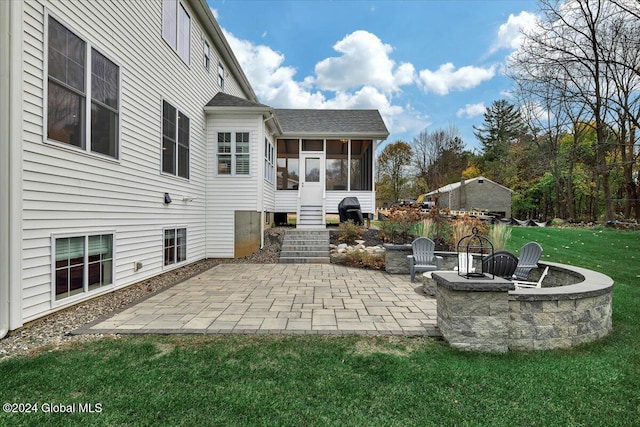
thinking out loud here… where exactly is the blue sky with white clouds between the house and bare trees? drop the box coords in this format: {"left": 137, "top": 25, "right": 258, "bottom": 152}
{"left": 208, "top": 0, "right": 536, "bottom": 149}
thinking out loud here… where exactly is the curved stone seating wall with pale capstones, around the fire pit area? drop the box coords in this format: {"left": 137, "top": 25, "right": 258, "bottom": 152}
{"left": 433, "top": 263, "right": 613, "bottom": 352}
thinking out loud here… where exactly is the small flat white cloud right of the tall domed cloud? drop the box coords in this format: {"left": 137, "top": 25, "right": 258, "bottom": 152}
{"left": 419, "top": 62, "right": 496, "bottom": 95}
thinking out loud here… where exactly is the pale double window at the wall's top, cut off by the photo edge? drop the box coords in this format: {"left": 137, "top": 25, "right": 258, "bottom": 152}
{"left": 162, "top": 0, "right": 191, "bottom": 65}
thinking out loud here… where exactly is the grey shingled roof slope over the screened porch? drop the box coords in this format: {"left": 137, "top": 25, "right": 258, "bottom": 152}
{"left": 274, "top": 109, "right": 389, "bottom": 139}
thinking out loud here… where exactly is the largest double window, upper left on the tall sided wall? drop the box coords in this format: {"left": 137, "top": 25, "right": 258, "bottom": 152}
{"left": 47, "top": 16, "right": 120, "bottom": 158}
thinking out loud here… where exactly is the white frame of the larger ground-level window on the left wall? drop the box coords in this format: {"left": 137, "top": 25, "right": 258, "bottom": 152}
{"left": 51, "top": 230, "right": 117, "bottom": 307}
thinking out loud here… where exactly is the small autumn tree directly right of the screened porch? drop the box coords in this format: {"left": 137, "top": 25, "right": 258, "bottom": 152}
{"left": 378, "top": 141, "right": 413, "bottom": 203}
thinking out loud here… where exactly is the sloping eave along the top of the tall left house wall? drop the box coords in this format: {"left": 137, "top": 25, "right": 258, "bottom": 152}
{"left": 189, "top": 0, "right": 258, "bottom": 102}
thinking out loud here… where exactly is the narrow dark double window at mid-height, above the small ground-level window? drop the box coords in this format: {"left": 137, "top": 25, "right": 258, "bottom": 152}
{"left": 162, "top": 101, "right": 189, "bottom": 178}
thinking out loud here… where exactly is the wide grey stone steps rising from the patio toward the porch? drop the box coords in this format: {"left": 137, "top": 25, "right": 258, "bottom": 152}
{"left": 280, "top": 230, "right": 330, "bottom": 264}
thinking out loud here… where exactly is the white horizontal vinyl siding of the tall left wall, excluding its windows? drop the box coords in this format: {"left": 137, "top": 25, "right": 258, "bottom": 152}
{"left": 16, "top": 0, "right": 245, "bottom": 322}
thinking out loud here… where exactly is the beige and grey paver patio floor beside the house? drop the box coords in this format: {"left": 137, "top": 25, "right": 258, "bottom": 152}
{"left": 74, "top": 264, "right": 440, "bottom": 336}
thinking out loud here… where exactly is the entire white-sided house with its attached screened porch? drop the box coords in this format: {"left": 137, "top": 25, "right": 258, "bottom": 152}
{"left": 0, "top": 0, "right": 388, "bottom": 337}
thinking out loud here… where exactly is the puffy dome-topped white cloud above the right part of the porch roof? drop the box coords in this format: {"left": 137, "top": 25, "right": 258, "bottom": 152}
{"left": 315, "top": 30, "right": 415, "bottom": 92}
